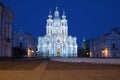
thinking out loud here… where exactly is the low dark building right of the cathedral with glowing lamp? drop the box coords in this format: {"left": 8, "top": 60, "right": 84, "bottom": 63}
{"left": 90, "top": 28, "right": 120, "bottom": 57}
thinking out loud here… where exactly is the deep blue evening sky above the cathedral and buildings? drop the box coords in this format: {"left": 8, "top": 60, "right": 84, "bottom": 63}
{"left": 0, "top": 0, "right": 120, "bottom": 47}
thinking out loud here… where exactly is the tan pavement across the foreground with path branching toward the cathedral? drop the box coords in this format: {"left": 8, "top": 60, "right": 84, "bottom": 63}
{"left": 0, "top": 61, "right": 120, "bottom": 80}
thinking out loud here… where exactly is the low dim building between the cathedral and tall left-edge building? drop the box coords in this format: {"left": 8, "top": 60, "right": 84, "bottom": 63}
{"left": 13, "top": 31, "right": 36, "bottom": 57}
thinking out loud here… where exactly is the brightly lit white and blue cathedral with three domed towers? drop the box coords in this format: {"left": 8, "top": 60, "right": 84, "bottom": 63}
{"left": 37, "top": 7, "right": 77, "bottom": 57}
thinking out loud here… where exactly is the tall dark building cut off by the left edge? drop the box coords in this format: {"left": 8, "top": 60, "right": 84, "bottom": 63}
{"left": 0, "top": 2, "right": 14, "bottom": 57}
